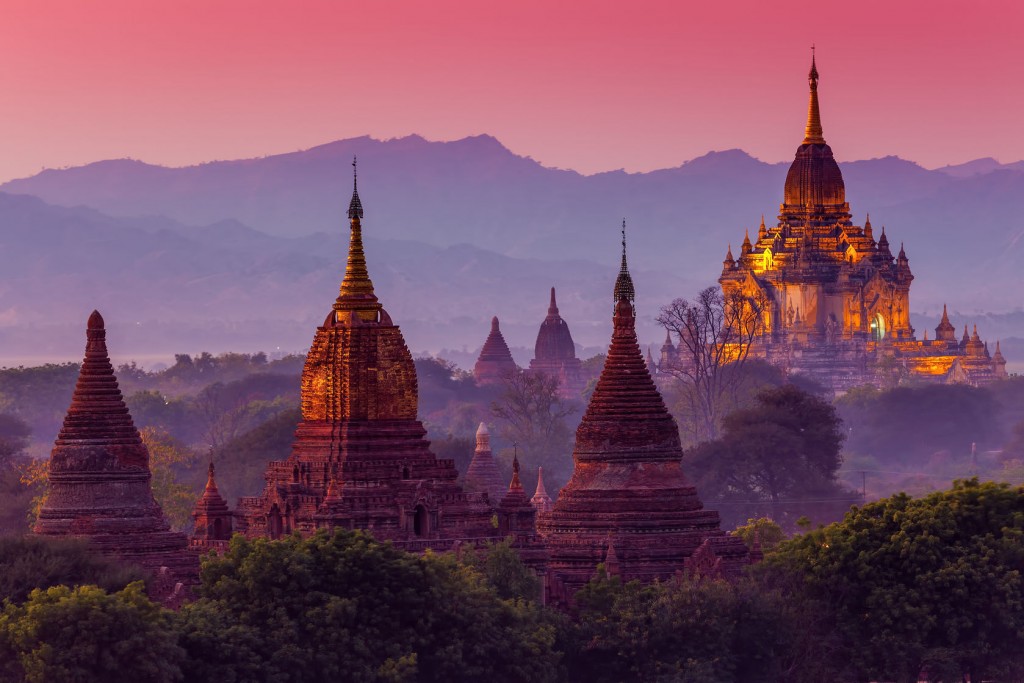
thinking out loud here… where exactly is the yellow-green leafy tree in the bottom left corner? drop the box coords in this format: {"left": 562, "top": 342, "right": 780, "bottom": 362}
{"left": 0, "top": 582, "right": 184, "bottom": 683}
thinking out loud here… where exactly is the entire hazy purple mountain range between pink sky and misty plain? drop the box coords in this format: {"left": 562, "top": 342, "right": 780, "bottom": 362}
{"left": 0, "top": 135, "right": 1024, "bottom": 368}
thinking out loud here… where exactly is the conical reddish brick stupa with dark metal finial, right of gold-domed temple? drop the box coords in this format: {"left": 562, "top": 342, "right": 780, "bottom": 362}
{"left": 538, "top": 224, "right": 749, "bottom": 604}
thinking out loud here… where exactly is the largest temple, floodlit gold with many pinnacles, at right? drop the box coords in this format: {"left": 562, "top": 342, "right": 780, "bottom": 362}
{"left": 720, "top": 57, "right": 1006, "bottom": 391}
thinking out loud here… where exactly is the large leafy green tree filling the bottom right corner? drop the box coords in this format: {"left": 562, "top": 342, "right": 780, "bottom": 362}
{"left": 762, "top": 480, "right": 1024, "bottom": 682}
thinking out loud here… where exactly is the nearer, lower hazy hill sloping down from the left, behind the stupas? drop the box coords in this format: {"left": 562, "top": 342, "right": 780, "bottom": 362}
{"left": 0, "top": 193, "right": 696, "bottom": 365}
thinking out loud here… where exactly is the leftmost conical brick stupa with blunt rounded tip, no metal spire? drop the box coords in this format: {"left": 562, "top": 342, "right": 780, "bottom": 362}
{"left": 33, "top": 311, "right": 199, "bottom": 599}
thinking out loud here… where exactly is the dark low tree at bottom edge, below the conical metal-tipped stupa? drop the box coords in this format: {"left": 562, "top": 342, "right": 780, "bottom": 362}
{"left": 567, "top": 570, "right": 794, "bottom": 683}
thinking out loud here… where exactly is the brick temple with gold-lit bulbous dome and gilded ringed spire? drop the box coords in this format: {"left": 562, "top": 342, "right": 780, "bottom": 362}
{"left": 236, "top": 163, "right": 497, "bottom": 550}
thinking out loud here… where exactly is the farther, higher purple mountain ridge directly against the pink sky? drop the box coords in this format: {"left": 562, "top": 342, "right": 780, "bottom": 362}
{"left": 2, "top": 135, "right": 1024, "bottom": 310}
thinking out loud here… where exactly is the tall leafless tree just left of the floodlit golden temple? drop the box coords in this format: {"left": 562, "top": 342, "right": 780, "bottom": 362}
{"left": 657, "top": 287, "right": 768, "bottom": 440}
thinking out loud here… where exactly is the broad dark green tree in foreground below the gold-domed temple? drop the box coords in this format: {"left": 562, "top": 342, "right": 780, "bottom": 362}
{"left": 181, "top": 529, "right": 559, "bottom": 683}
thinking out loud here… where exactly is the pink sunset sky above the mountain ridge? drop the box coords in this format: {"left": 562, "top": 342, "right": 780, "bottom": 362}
{"left": 0, "top": 0, "right": 1024, "bottom": 179}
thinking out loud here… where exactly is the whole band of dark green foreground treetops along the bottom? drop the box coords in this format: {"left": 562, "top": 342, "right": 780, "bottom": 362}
{"left": 0, "top": 480, "right": 1024, "bottom": 683}
